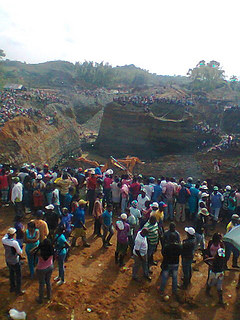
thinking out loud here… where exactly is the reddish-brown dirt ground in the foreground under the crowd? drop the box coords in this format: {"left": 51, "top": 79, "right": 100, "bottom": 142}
{"left": 0, "top": 208, "right": 240, "bottom": 320}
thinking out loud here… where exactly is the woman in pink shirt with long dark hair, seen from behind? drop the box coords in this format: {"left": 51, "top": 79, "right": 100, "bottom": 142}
{"left": 32, "top": 239, "right": 53, "bottom": 303}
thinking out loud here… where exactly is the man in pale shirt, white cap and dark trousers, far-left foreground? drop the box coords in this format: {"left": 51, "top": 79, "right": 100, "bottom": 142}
{"left": 2, "top": 228, "right": 25, "bottom": 295}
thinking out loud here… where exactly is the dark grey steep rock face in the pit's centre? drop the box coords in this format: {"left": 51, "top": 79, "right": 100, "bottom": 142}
{"left": 96, "top": 103, "right": 216, "bottom": 158}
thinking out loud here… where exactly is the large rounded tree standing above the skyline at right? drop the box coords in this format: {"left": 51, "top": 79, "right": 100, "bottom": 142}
{"left": 187, "top": 60, "right": 225, "bottom": 91}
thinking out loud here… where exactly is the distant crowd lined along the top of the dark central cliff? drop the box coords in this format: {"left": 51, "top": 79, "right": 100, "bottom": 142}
{"left": 113, "top": 95, "right": 194, "bottom": 107}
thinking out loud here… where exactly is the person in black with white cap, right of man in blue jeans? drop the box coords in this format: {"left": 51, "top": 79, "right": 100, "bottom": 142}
{"left": 182, "top": 227, "right": 196, "bottom": 289}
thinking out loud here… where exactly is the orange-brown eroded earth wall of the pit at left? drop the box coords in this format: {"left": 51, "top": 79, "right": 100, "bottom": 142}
{"left": 0, "top": 117, "right": 80, "bottom": 165}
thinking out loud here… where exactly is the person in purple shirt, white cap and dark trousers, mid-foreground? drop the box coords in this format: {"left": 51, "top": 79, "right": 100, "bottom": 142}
{"left": 115, "top": 213, "right": 130, "bottom": 267}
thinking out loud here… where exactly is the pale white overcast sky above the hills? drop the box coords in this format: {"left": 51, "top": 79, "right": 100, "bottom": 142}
{"left": 0, "top": 0, "right": 240, "bottom": 76}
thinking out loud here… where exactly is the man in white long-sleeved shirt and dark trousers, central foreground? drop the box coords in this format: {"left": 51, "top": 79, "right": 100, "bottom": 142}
{"left": 132, "top": 228, "right": 152, "bottom": 281}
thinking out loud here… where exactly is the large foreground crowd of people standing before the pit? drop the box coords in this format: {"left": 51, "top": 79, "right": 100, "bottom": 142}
{"left": 0, "top": 163, "right": 240, "bottom": 304}
